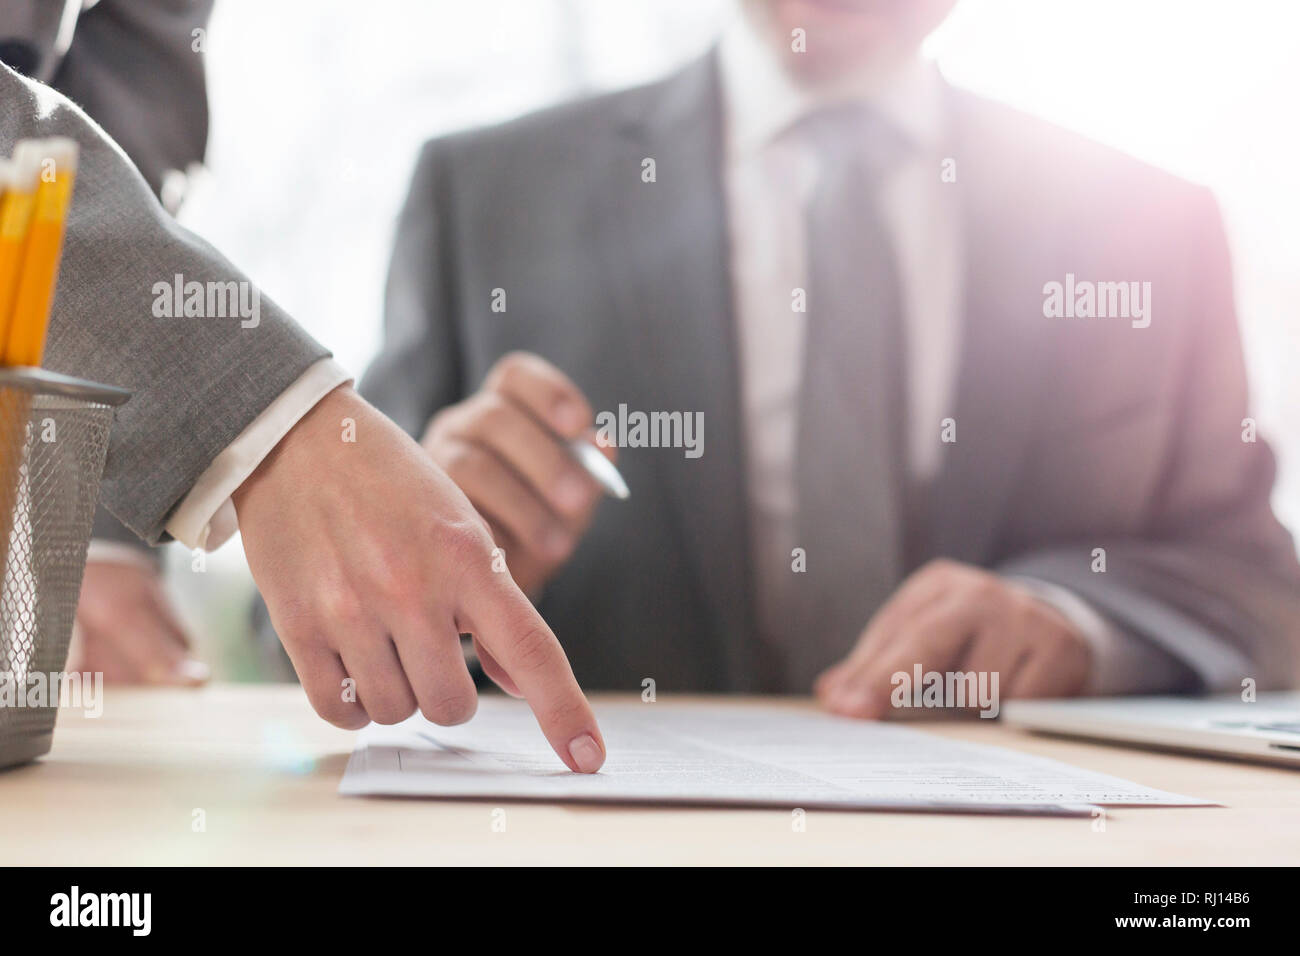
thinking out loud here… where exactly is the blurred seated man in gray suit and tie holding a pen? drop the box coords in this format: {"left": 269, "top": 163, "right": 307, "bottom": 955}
{"left": 351, "top": 0, "right": 1300, "bottom": 717}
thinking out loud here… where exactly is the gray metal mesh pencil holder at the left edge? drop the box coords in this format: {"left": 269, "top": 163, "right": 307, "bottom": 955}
{"left": 0, "top": 368, "right": 130, "bottom": 767}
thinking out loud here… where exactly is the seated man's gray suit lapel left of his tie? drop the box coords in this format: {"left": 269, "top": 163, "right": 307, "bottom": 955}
{"left": 589, "top": 53, "right": 757, "bottom": 689}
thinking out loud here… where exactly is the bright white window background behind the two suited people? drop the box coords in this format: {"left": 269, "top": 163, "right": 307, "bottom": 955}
{"left": 172, "top": 0, "right": 1300, "bottom": 676}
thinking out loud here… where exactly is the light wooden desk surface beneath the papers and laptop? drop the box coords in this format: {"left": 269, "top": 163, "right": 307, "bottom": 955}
{"left": 0, "top": 684, "right": 1300, "bottom": 865}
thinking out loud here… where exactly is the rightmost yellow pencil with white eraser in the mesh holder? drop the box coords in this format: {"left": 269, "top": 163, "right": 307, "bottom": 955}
{"left": 3, "top": 138, "right": 77, "bottom": 365}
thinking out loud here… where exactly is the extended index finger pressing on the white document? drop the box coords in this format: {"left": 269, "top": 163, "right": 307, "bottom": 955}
{"left": 458, "top": 572, "right": 605, "bottom": 774}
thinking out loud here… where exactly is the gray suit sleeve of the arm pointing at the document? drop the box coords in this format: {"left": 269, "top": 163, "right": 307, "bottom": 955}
{"left": 0, "top": 66, "right": 329, "bottom": 542}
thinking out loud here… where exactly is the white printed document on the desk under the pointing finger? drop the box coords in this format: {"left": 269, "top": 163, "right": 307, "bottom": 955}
{"left": 339, "top": 697, "right": 1210, "bottom": 816}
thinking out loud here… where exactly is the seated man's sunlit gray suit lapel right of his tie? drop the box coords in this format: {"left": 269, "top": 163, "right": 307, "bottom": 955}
{"left": 930, "top": 90, "right": 1057, "bottom": 563}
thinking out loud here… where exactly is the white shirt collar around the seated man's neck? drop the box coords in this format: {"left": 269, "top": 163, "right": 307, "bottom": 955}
{"left": 718, "top": 16, "right": 944, "bottom": 156}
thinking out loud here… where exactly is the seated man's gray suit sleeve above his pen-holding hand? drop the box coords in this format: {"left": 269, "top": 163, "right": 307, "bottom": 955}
{"left": 360, "top": 142, "right": 464, "bottom": 440}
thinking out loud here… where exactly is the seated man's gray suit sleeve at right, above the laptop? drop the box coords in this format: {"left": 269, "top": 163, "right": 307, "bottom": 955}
{"left": 1000, "top": 194, "right": 1300, "bottom": 691}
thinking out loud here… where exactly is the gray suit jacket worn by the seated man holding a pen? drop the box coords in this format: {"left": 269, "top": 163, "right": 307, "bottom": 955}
{"left": 363, "top": 57, "right": 1300, "bottom": 691}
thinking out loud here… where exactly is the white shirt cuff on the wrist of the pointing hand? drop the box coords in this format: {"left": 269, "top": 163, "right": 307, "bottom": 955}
{"left": 166, "top": 359, "right": 352, "bottom": 551}
